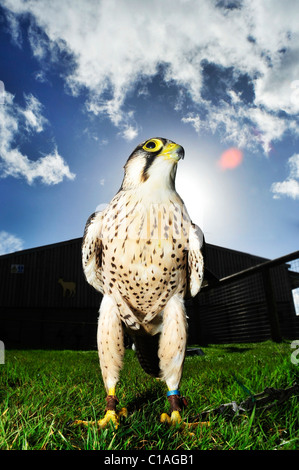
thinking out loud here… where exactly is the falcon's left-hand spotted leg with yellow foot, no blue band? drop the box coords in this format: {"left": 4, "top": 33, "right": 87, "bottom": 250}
{"left": 97, "top": 295, "right": 126, "bottom": 428}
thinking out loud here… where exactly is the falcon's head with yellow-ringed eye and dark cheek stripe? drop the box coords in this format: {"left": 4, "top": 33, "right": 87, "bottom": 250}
{"left": 121, "top": 137, "right": 185, "bottom": 190}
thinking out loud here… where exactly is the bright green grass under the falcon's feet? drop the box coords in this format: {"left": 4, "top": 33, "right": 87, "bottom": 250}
{"left": 0, "top": 342, "right": 299, "bottom": 450}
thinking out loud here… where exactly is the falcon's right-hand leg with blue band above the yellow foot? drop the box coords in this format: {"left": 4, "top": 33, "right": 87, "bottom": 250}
{"left": 158, "top": 295, "right": 187, "bottom": 423}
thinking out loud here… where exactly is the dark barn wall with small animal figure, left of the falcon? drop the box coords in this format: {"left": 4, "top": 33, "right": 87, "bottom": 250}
{"left": 0, "top": 238, "right": 101, "bottom": 349}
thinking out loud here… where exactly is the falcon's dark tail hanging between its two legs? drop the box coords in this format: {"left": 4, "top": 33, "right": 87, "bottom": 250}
{"left": 133, "top": 334, "right": 160, "bottom": 377}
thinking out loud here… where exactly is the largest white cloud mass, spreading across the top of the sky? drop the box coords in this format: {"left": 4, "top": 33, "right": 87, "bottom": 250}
{"left": 3, "top": 0, "right": 299, "bottom": 153}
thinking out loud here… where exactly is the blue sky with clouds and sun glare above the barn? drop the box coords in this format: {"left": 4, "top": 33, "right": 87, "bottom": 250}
{"left": 0, "top": 0, "right": 299, "bottom": 258}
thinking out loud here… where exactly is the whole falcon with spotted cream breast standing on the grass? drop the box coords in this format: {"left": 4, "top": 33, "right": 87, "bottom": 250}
{"left": 82, "top": 137, "right": 204, "bottom": 427}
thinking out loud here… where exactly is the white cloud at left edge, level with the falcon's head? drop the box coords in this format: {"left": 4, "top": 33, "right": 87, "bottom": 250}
{"left": 0, "top": 91, "right": 75, "bottom": 185}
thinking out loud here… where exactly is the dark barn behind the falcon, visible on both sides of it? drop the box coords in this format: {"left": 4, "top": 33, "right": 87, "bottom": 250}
{"left": 0, "top": 238, "right": 299, "bottom": 350}
